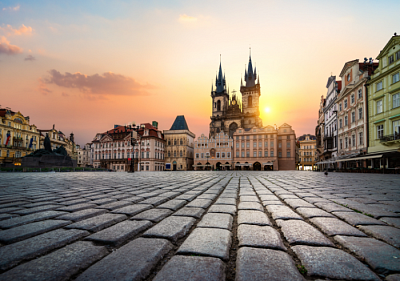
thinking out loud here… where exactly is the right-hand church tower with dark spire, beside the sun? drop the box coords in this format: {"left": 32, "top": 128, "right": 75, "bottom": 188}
{"left": 240, "top": 51, "right": 262, "bottom": 128}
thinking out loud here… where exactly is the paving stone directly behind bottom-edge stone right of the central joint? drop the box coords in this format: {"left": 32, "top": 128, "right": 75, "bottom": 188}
{"left": 238, "top": 224, "right": 286, "bottom": 251}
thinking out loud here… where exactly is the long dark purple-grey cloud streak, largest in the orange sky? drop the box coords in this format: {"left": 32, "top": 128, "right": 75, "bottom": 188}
{"left": 44, "top": 69, "right": 154, "bottom": 96}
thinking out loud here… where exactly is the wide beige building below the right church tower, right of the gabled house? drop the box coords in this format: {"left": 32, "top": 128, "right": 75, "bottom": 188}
{"left": 233, "top": 123, "right": 296, "bottom": 171}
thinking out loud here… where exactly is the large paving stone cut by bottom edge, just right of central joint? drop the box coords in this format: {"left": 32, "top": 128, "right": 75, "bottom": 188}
{"left": 236, "top": 247, "right": 305, "bottom": 281}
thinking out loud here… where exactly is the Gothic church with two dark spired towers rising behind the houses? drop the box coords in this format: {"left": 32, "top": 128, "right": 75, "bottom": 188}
{"left": 210, "top": 53, "right": 262, "bottom": 137}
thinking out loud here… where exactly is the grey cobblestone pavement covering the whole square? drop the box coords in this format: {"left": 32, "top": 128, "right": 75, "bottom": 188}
{"left": 0, "top": 171, "right": 400, "bottom": 281}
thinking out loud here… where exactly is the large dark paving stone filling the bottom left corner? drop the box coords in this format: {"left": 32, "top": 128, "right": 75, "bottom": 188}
{"left": 0, "top": 242, "right": 108, "bottom": 280}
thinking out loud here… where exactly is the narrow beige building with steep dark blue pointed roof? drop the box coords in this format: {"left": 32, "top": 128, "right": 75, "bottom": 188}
{"left": 164, "top": 115, "right": 196, "bottom": 171}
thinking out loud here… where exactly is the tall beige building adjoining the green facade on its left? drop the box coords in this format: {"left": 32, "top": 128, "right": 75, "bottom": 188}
{"left": 337, "top": 59, "right": 377, "bottom": 168}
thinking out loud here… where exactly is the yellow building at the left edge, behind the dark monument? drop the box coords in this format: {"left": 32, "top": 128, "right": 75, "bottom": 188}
{"left": 0, "top": 108, "right": 39, "bottom": 166}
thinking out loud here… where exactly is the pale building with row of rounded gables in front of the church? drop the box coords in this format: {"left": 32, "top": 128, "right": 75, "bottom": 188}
{"left": 193, "top": 132, "right": 233, "bottom": 168}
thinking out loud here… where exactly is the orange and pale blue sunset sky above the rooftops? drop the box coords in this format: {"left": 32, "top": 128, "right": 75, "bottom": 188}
{"left": 0, "top": 0, "right": 400, "bottom": 145}
